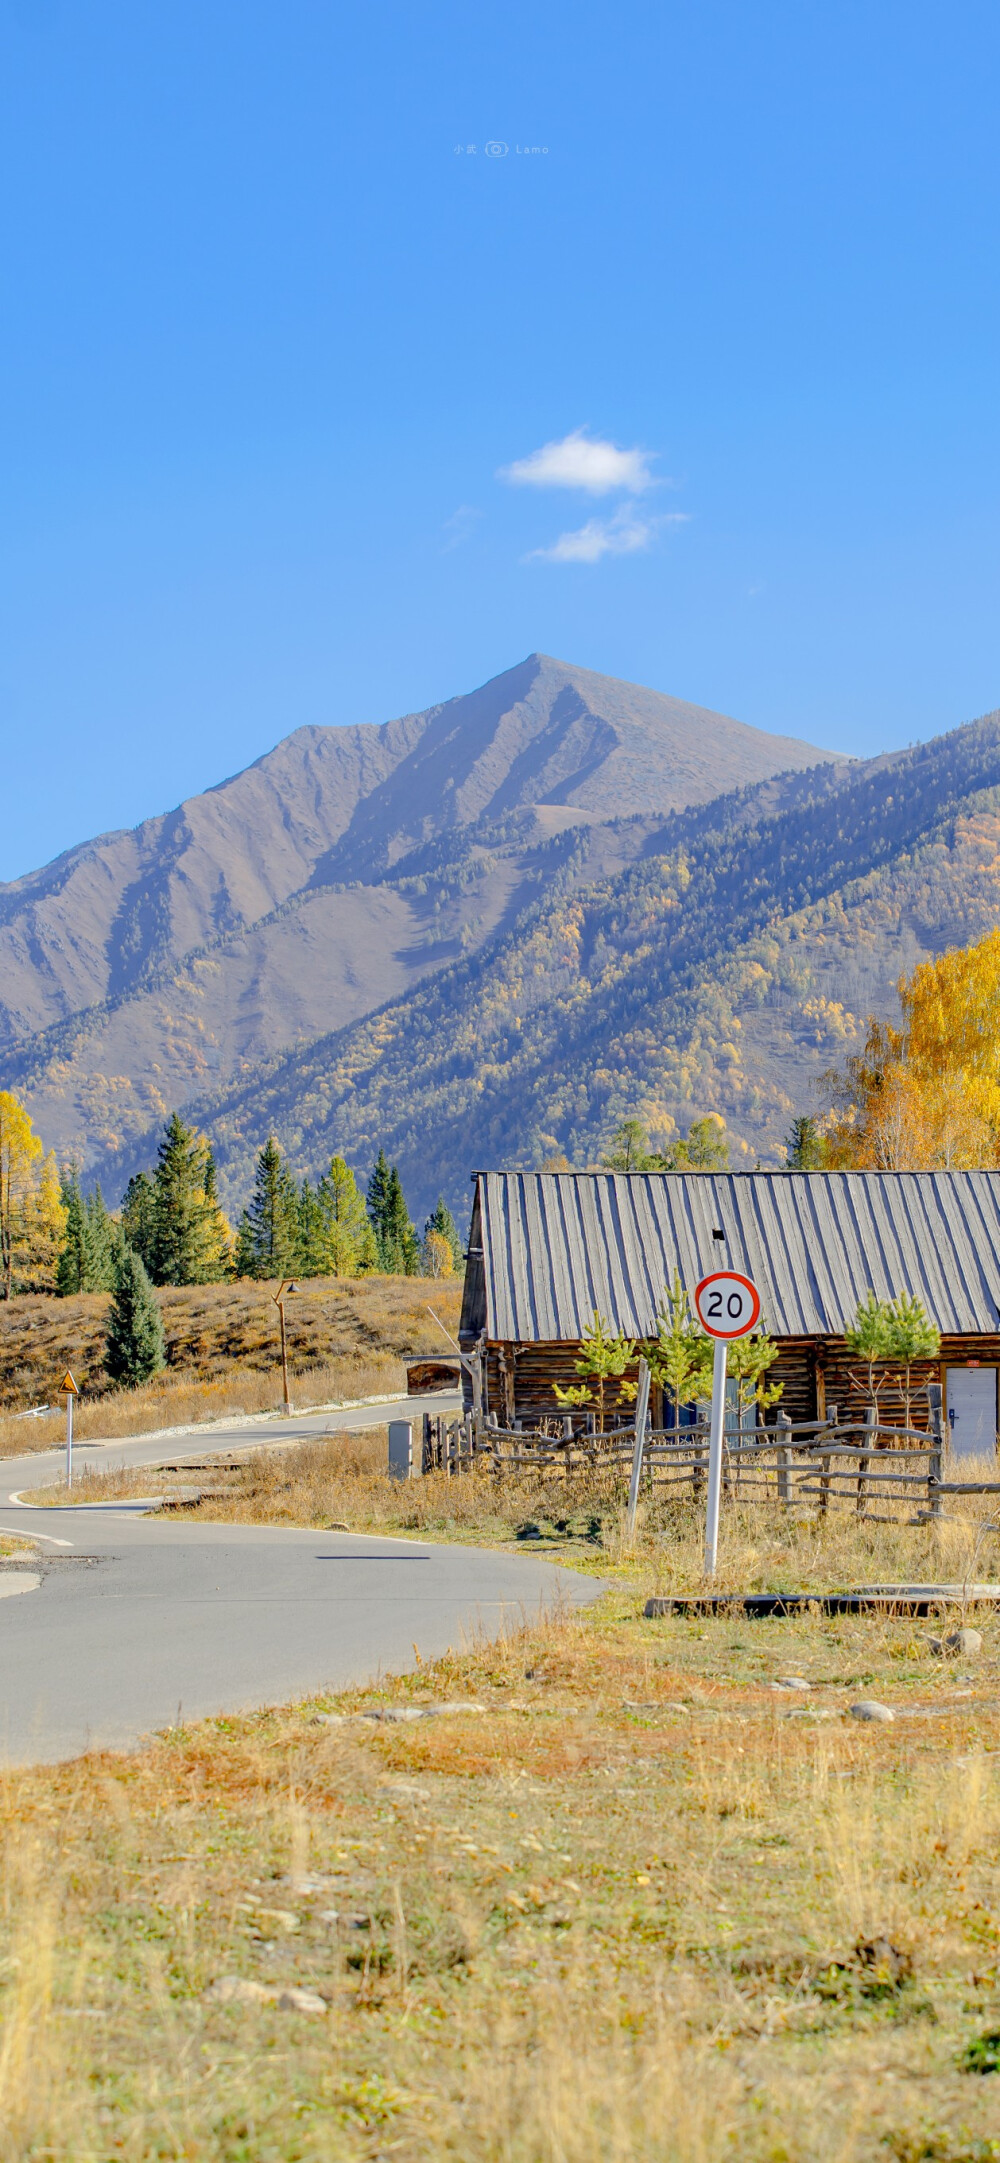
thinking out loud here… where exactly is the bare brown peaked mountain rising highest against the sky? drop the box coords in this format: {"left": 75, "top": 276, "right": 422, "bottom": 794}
{"left": 0, "top": 653, "right": 831, "bottom": 1166}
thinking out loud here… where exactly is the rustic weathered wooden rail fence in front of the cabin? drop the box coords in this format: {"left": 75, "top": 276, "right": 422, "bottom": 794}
{"left": 422, "top": 1408, "right": 1000, "bottom": 1523}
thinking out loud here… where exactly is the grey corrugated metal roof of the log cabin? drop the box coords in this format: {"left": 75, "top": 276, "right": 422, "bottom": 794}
{"left": 478, "top": 1172, "right": 1000, "bottom": 1343}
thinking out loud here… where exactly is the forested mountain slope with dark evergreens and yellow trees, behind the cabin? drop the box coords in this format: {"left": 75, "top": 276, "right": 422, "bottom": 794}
{"left": 93, "top": 712, "right": 1000, "bottom": 1213}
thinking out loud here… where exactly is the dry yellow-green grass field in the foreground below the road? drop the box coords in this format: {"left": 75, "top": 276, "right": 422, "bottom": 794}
{"left": 0, "top": 1577, "right": 1000, "bottom": 2163}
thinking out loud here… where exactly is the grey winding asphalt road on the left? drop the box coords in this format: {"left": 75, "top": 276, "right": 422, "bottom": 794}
{"left": 0, "top": 1397, "right": 597, "bottom": 1765}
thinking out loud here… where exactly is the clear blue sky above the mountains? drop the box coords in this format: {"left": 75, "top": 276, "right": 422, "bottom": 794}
{"left": 0, "top": 0, "right": 1000, "bottom": 878}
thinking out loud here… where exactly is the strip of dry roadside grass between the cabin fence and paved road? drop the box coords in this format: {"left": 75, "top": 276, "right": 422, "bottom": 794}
{"left": 24, "top": 1425, "right": 1000, "bottom": 1592}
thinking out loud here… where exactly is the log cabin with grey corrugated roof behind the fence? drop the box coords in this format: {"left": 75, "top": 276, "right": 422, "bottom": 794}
{"left": 461, "top": 1172, "right": 1000, "bottom": 1456}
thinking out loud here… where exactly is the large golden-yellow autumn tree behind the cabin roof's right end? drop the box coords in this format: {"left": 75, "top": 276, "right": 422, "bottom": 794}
{"left": 829, "top": 928, "right": 1000, "bottom": 1172}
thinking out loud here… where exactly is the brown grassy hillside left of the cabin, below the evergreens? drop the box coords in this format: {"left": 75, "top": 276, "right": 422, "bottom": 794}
{"left": 0, "top": 1276, "right": 461, "bottom": 1456}
